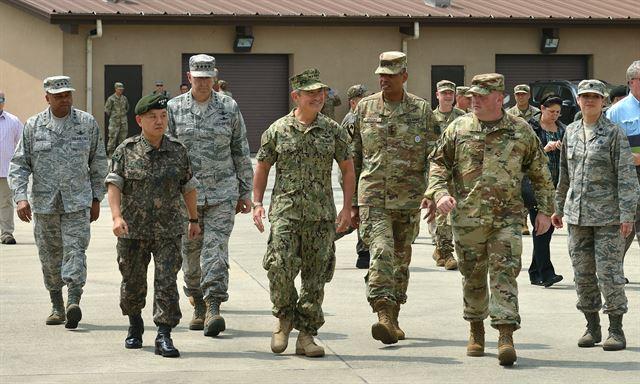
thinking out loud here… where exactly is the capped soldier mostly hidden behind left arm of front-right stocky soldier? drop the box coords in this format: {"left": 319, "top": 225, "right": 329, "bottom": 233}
{"left": 433, "top": 80, "right": 466, "bottom": 270}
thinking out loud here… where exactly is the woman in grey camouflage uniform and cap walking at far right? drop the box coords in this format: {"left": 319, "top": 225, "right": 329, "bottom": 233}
{"left": 552, "top": 80, "right": 640, "bottom": 351}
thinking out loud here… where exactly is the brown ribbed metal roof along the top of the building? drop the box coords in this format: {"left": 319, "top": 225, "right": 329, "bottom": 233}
{"left": 7, "top": 0, "right": 640, "bottom": 24}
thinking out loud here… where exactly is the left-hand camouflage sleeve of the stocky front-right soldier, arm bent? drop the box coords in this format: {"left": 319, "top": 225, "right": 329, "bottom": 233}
{"left": 425, "top": 123, "right": 456, "bottom": 202}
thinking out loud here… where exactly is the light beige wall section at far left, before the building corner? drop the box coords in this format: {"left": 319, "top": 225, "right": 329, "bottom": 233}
{"left": 0, "top": 2, "right": 63, "bottom": 122}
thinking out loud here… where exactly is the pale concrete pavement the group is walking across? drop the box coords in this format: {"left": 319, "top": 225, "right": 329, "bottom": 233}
{"left": 0, "top": 181, "right": 640, "bottom": 383}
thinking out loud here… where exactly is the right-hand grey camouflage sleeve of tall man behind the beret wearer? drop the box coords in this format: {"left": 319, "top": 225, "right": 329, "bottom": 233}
{"left": 231, "top": 102, "right": 253, "bottom": 199}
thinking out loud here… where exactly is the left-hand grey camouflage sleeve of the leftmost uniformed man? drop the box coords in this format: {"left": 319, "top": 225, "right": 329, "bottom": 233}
{"left": 7, "top": 119, "right": 35, "bottom": 203}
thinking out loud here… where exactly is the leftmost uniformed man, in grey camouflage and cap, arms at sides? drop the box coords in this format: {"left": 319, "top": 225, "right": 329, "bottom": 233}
{"left": 8, "top": 76, "right": 107, "bottom": 329}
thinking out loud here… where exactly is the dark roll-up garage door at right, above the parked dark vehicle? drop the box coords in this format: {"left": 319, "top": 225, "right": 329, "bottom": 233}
{"left": 496, "top": 55, "right": 588, "bottom": 105}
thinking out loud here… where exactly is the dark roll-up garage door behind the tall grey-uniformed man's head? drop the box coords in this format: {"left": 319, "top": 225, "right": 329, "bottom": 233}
{"left": 182, "top": 53, "right": 289, "bottom": 152}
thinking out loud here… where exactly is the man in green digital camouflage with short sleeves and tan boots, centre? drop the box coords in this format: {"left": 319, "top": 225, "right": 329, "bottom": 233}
{"left": 253, "top": 69, "right": 355, "bottom": 357}
